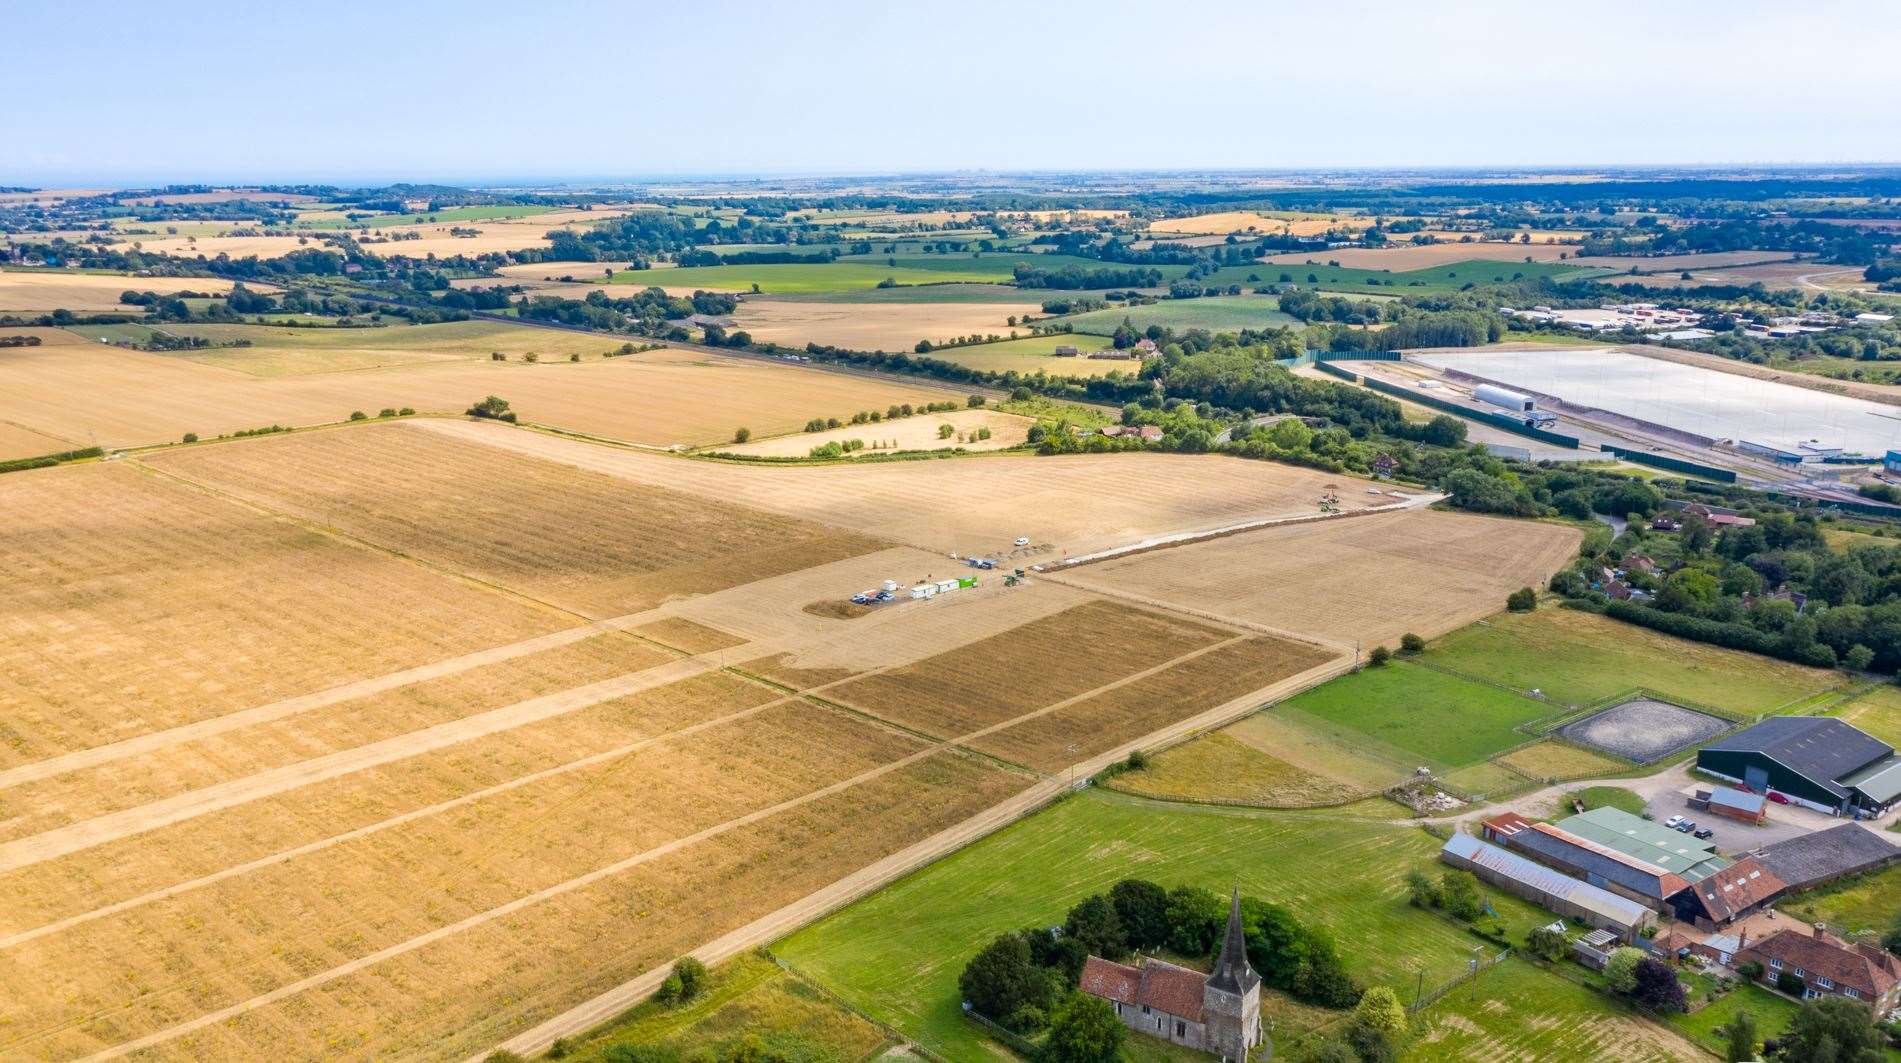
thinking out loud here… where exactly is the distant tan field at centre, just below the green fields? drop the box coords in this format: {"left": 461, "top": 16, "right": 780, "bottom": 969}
{"left": 734, "top": 299, "right": 1042, "bottom": 350}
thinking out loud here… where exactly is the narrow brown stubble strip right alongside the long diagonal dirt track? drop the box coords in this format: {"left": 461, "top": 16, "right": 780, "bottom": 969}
{"left": 973, "top": 637, "right": 1335, "bottom": 772}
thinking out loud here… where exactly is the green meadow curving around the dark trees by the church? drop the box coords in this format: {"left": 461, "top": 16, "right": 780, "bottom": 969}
{"left": 772, "top": 791, "right": 1549, "bottom": 1063}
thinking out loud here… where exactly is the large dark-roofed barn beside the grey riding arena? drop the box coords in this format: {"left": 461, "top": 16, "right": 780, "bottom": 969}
{"left": 1696, "top": 717, "right": 1901, "bottom": 816}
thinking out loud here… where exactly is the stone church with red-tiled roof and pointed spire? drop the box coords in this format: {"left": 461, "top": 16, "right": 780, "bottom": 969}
{"left": 1078, "top": 890, "right": 1274, "bottom": 1063}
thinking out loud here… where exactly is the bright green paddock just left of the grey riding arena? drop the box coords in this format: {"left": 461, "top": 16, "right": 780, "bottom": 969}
{"left": 1274, "top": 662, "right": 1551, "bottom": 770}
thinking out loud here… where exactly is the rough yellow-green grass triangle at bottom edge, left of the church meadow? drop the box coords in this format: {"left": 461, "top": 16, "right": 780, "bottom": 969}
{"left": 565, "top": 953, "right": 892, "bottom": 1063}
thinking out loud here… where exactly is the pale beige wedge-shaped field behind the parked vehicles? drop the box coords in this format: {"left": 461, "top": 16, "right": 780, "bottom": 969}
{"left": 420, "top": 420, "right": 1399, "bottom": 565}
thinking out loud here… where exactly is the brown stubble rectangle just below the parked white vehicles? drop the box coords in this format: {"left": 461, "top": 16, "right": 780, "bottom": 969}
{"left": 825, "top": 603, "right": 1228, "bottom": 741}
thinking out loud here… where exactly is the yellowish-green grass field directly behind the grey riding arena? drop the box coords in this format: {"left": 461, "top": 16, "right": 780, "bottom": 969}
{"left": 1426, "top": 609, "right": 1848, "bottom": 715}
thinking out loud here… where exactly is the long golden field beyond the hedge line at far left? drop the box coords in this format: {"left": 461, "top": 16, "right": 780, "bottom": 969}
{"left": 0, "top": 334, "right": 962, "bottom": 447}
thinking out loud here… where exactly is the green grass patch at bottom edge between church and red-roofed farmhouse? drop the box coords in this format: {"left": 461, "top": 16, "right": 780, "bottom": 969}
{"left": 1403, "top": 960, "right": 1701, "bottom": 1063}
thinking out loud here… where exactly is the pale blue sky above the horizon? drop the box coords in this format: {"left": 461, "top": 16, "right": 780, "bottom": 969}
{"left": 0, "top": 0, "right": 1901, "bottom": 184}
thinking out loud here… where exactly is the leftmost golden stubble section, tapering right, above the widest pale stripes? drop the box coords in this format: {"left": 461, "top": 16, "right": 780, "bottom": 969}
{"left": 0, "top": 464, "right": 572, "bottom": 766}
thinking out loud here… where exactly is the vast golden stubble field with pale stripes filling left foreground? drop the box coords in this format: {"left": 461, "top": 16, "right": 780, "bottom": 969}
{"left": 0, "top": 422, "right": 1414, "bottom": 1059}
